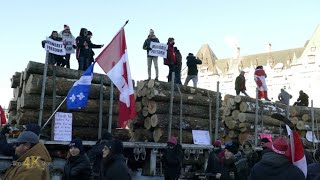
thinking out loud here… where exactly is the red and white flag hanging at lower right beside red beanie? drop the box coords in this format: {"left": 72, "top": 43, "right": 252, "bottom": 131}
{"left": 290, "top": 130, "right": 308, "bottom": 177}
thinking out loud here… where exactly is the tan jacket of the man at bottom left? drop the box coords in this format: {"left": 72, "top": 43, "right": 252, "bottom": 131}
{"left": 4, "top": 143, "right": 51, "bottom": 180}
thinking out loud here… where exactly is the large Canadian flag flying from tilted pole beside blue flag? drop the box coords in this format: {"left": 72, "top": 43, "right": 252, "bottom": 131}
{"left": 96, "top": 28, "right": 137, "bottom": 128}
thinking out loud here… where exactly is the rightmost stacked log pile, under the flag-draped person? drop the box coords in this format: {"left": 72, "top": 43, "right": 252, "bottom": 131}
{"left": 221, "top": 95, "right": 320, "bottom": 143}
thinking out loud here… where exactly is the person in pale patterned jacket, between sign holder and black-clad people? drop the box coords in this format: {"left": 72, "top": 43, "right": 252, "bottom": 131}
{"left": 59, "top": 24, "right": 76, "bottom": 68}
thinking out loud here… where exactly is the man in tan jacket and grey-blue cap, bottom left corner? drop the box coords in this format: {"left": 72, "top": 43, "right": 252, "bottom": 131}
{"left": 3, "top": 131, "right": 51, "bottom": 180}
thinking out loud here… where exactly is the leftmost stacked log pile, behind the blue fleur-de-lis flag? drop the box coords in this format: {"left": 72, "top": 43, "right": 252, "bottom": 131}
{"left": 9, "top": 61, "right": 130, "bottom": 140}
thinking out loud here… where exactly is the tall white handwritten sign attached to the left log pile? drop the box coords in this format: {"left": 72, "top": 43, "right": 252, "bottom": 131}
{"left": 54, "top": 112, "right": 72, "bottom": 141}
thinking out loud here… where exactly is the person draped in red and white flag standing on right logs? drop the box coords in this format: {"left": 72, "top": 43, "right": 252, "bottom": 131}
{"left": 254, "top": 66, "right": 270, "bottom": 101}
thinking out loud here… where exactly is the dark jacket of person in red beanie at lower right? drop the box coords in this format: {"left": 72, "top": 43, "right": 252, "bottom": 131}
{"left": 248, "top": 152, "right": 305, "bottom": 180}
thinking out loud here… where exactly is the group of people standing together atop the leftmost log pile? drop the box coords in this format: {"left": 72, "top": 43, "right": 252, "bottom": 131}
{"left": 42, "top": 25, "right": 104, "bottom": 71}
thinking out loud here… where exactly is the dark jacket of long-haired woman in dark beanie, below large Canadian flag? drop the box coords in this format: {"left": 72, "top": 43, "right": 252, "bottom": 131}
{"left": 100, "top": 154, "right": 131, "bottom": 180}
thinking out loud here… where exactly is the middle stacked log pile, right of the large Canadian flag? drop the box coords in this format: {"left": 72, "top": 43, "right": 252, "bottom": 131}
{"left": 129, "top": 79, "right": 221, "bottom": 143}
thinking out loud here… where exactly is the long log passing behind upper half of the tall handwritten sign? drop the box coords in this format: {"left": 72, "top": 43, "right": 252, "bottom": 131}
{"left": 17, "top": 109, "right": 118, "bottom": 130}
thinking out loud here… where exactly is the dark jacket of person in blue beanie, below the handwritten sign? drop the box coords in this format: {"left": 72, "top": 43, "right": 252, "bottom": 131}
{"left": 62, "top": 154, "right": 93, "bottom": 180}
